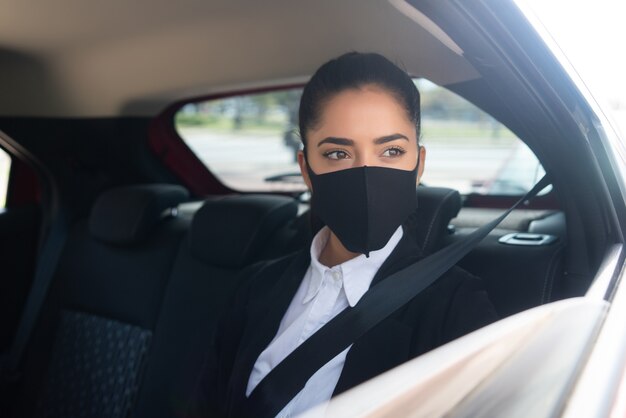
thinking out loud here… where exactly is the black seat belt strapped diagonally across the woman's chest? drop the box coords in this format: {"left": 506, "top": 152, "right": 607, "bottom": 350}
{"left": 244, "top": 176, "right": 550, "bottom": 417}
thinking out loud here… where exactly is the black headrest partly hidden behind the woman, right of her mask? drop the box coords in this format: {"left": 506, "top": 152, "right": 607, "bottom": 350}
{"left": 416, "top": 186, "right": 461, "bottom": 254}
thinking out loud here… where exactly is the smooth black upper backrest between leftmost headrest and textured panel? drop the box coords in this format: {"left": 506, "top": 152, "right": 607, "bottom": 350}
{"left": 58, "top": 218, "right": 189, "bottom": 328}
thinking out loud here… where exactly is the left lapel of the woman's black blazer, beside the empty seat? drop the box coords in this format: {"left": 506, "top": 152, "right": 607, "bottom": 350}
{"left": 229, "top": 248, "right": 310, "bottom": 416}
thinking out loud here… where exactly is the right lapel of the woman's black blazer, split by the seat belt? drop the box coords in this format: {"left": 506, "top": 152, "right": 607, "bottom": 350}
{"left": 333, "top": 224, "right": 423, "bottom": 396}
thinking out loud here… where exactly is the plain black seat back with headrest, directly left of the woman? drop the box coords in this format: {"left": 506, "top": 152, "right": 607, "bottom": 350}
{"left": 135, "top": 195, "right": 297, "bottom": 418}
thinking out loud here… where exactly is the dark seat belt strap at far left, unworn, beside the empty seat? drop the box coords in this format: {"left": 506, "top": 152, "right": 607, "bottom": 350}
{"left": 0, "top": 208, "right": 67, "bottom": 390}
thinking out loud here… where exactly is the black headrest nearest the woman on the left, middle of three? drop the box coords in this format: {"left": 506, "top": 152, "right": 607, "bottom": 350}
{"left": 189, "top": 195, "right": 298, "bottom": 268}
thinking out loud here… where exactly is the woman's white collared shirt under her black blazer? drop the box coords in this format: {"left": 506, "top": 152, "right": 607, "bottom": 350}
{"left": 246, "top": 226, "right": 403, "bottom": 418}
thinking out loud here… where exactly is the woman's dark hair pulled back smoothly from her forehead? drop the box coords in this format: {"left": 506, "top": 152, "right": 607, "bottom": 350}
{"left": 299, "top": 52, "right": 420, "bottom": 154}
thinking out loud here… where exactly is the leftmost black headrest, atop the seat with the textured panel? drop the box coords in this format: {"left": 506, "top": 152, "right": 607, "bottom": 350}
{"left": 89, "top": 184, "right": 189, "bottom": 245}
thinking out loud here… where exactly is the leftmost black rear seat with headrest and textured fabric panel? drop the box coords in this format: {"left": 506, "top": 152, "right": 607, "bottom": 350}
{"left": 15, "top": 185, "right": 188, "bottom": 417}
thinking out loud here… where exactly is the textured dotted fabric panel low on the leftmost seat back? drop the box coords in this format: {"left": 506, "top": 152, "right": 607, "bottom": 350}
{"left": 36, "top": 311, "right": 152, "bottom": 418}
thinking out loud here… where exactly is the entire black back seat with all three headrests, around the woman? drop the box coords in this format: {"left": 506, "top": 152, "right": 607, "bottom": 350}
{"left": 9, "top": 185, "right": 564, "bottom": 417}
